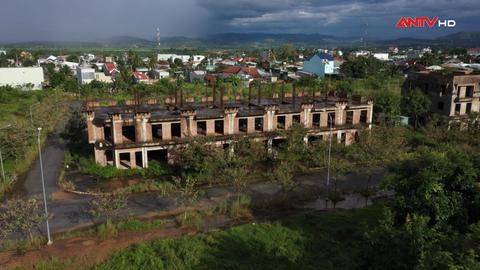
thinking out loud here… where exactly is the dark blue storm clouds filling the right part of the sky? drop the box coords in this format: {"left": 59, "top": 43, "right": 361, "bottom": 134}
{"left": 197, "top": 0, "right": 480, "bottom": 38}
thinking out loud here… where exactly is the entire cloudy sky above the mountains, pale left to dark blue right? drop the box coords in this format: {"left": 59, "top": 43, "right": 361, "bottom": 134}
{"left": 0, "top": 0, "right": 480, "bottom": 42}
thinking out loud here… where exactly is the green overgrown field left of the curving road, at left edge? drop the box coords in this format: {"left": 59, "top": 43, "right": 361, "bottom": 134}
{"left": 0, "top": 86, "right": 69, "bottom": 197}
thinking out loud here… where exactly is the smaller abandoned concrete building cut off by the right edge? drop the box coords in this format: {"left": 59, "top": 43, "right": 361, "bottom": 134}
{"left": 402, "top": 70, "right": 480, "bottom": 119}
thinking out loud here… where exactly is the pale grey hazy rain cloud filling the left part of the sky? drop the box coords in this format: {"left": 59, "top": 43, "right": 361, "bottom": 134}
{"left": 0, "top": 0, "right": 210, "bottom": 42}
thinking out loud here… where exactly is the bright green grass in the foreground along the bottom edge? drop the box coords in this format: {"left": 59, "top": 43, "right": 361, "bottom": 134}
{"left": 93, "top": 206, "right": 381, "bottom": 269}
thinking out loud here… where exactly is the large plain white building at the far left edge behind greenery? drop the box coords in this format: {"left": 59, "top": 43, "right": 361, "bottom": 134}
{"left": 0, "top": 67, "right": 44, "bottom": 90}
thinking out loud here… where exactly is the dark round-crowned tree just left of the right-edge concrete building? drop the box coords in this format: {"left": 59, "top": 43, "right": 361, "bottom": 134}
{"left": 402, "top": 88, "right": 432, "bottom": 128}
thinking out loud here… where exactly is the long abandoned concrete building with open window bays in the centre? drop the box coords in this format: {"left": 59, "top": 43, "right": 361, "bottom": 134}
{"left": 84, "top": 92, "right": 373, "bottom": 169}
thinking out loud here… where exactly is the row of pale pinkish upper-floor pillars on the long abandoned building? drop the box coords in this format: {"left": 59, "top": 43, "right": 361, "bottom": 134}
{"left": 87, "top": 102, "right": 373, "bottom": 144}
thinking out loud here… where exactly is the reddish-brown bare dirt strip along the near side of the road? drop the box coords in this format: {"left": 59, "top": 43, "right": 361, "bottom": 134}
{"left": 0, "top": 217, "right": 232, "bottom": 269}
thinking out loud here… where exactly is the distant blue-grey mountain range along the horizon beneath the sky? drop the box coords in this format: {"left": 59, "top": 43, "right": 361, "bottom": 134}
{"left": 4, "top": 32, "right": 480, "bottom": 49}
